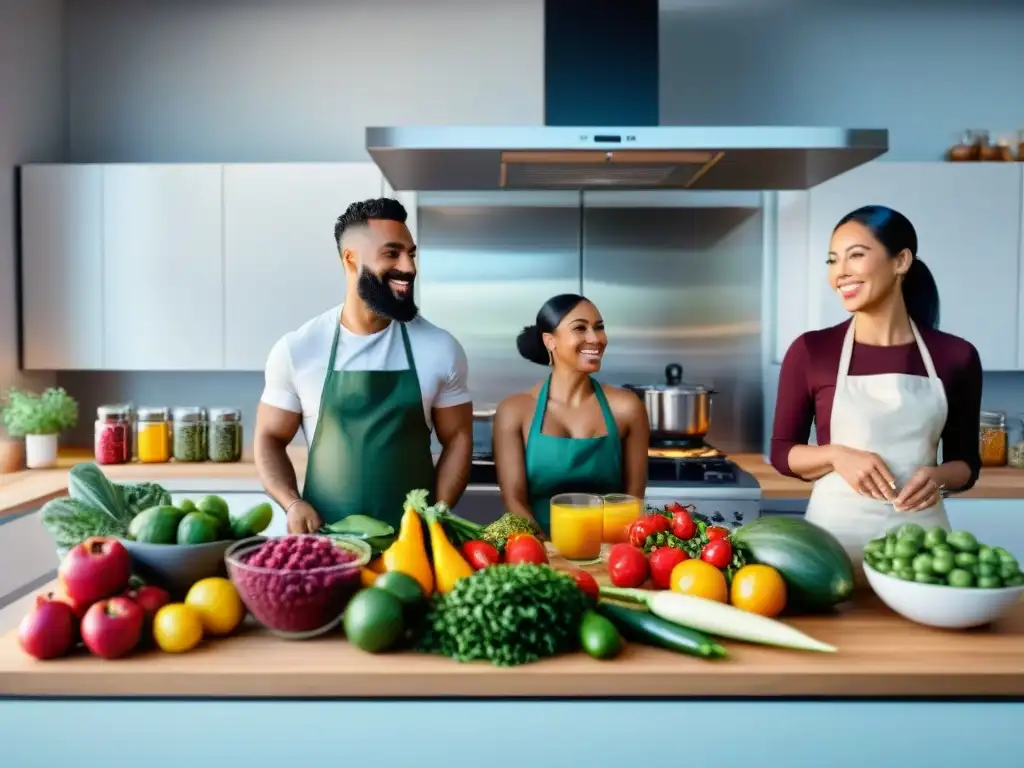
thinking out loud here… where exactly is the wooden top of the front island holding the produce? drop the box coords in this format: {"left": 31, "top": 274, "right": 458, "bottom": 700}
{"left": 6, "top": 558, "right": 1024, "bottom": 698}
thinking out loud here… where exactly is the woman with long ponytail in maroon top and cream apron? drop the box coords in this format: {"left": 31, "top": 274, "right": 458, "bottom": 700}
{"left": 771, "top": 206, "right": 981, "bottom": 581}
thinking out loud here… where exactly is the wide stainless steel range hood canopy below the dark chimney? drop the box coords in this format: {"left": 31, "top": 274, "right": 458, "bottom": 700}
{"left": 367, "top": 126, "right": 888, "bottom": 190}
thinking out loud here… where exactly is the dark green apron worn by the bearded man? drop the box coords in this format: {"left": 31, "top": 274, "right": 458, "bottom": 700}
{"left": 302, "top": 318, "right": 434, "bottom": 530}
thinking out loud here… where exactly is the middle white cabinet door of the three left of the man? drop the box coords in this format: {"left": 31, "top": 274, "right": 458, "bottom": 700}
{"left": 102, "top": 165, "right": 224, "bottom": 371}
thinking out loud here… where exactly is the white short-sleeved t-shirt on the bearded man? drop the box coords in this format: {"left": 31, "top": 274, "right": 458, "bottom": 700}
{"left": 260, "top": 305, "right": 471, "bottom": 445}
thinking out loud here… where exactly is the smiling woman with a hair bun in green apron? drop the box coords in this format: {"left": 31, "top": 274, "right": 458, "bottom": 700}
{"left": 494, "top": 294, "right": 649, "bottom": 535}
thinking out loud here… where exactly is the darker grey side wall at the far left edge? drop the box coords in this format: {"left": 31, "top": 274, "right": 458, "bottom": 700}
{"left": 0, "top": 0, "right": 68, "bottom": 423}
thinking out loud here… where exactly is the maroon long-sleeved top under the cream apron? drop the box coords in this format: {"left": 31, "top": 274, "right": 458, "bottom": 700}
{"left": 771, "top": 321, "right": 981, "bottom": 490}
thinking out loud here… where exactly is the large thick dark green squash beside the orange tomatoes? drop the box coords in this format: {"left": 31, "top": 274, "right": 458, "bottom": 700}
{"left": 731, "top": 515, "right": 853, "bottom": 610}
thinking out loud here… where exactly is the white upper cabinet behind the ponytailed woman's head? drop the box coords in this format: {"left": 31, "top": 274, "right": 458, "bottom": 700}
{"left": 807, "top": 162, "right": 1024, "bottom": 371}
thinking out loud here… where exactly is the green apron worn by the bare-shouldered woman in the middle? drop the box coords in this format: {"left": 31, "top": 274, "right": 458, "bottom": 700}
{"left": 526, "top": 377, "right": 625, "bottom": 536}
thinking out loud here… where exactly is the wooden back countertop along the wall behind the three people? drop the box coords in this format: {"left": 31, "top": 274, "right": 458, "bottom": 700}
{"left": 0, "top": 447, "right": 1024, "bottom": 517}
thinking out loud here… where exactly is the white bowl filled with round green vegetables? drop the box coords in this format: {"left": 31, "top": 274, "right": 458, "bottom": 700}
{"left": 864, "top": 522, "right": 1024, "bottom": 630}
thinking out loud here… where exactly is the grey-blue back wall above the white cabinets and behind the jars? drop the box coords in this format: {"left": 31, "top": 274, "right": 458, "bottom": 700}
{"left": 22, "top": 0, "right": 1024, "bottom": 448}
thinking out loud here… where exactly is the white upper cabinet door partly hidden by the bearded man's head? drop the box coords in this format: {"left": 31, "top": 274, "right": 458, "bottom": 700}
{"left": 222, "top": 163, "right": 383, "bottom": 371}
